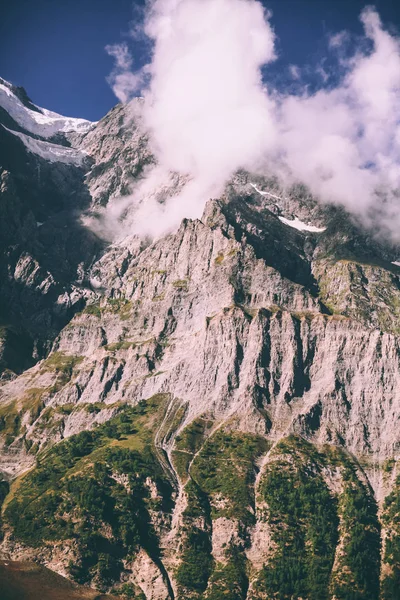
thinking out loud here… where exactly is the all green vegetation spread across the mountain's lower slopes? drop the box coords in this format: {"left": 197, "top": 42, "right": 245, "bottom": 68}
{"left": 0, "top": 394, "right": 388, "bottom": 600}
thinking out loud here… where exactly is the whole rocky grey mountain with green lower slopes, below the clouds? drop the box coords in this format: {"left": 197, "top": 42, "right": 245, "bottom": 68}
{"left": 0, "top": 80, "right": 400, "bottom": 600}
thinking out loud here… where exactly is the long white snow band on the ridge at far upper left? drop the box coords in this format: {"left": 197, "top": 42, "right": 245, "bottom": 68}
{"left": 0, "top": 83, "right": 95, "bottom": 138}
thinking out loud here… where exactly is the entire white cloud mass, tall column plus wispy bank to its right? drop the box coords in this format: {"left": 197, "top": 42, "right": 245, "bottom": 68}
{"left": 108, "top": 0, "right": 400, "bottom": 239}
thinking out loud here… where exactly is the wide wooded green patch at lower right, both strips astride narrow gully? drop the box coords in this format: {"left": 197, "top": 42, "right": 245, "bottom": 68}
{"left": 256, "top": 437, "right": 380, "bottom": 600}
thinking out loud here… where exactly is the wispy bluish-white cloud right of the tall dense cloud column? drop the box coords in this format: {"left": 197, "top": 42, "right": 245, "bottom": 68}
{"left": 280, "top": 9, "right": 400, "bottom": 235}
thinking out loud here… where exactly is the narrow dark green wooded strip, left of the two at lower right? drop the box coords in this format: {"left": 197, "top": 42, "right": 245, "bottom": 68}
{"left": 257, "top": 437, "right": 338, "bottom": 600}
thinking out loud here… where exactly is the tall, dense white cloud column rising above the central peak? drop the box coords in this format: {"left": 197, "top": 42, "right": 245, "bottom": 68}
{"left": 104, "top": 0, "right": 276, "bottom": 235}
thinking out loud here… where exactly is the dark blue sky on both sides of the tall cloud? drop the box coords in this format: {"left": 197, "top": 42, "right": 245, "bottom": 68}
{"left": 0, "top": 0, "right": 400, "bottom": 120}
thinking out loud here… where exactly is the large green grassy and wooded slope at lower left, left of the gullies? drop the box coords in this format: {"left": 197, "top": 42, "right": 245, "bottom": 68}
{"left": 4, "top": 395, "right": 172, "bottom": 586}
